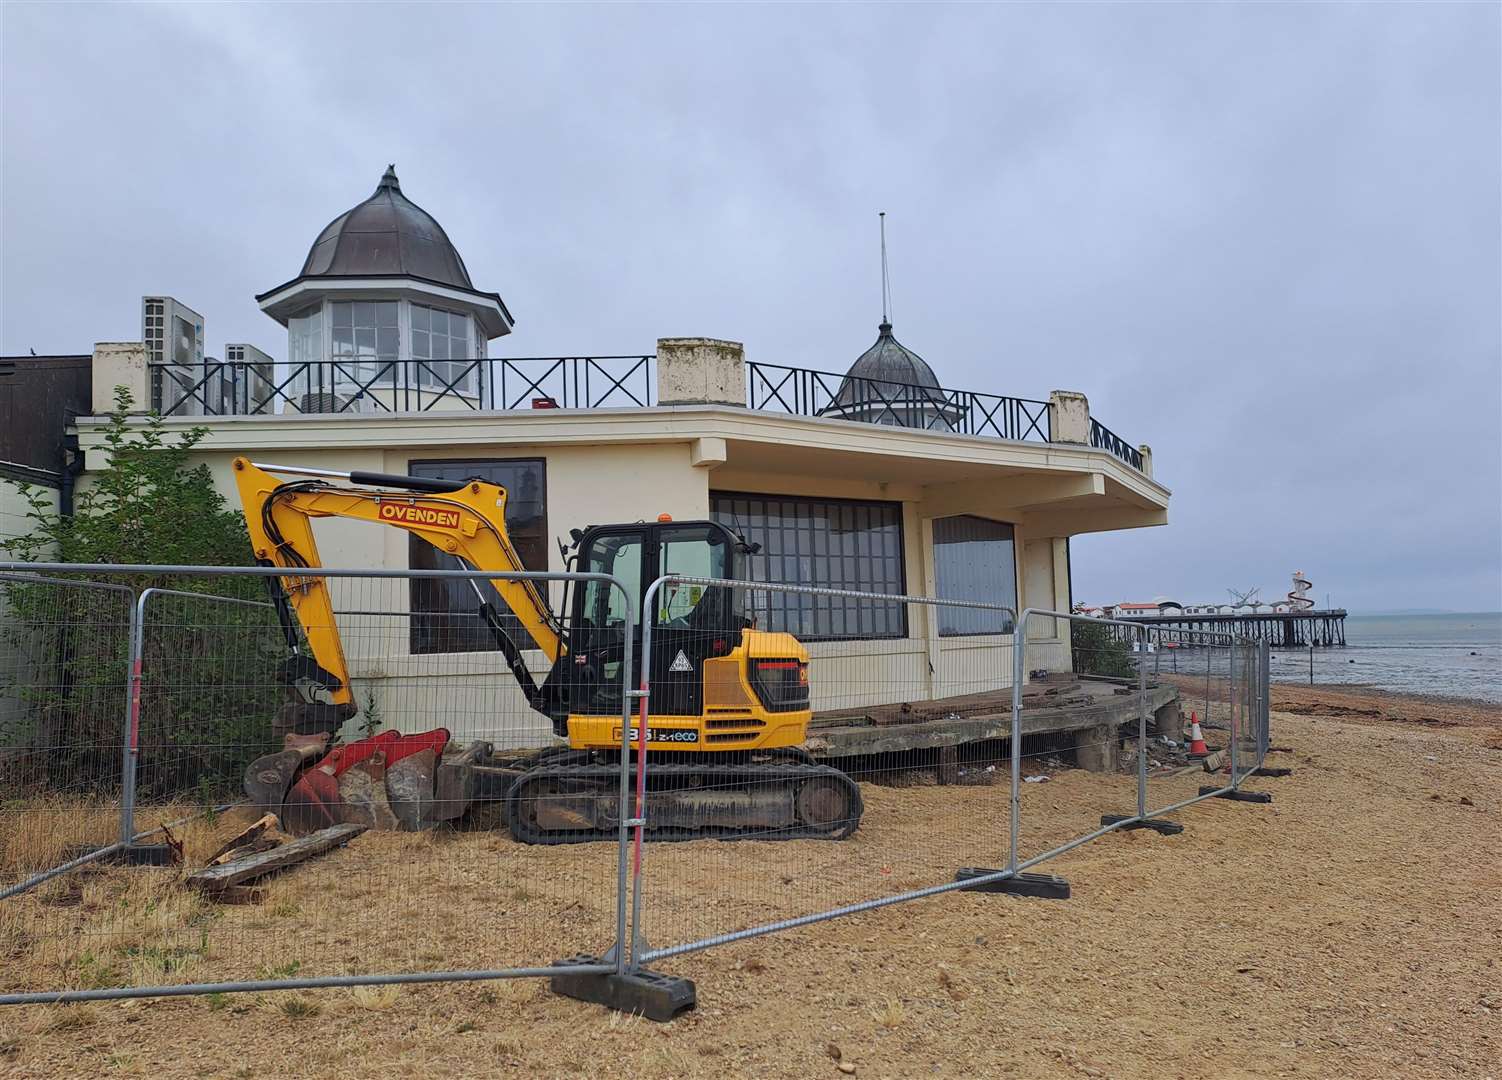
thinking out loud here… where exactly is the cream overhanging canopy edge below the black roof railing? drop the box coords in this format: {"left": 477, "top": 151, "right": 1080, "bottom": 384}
{"left": 80, "top": 406, "right": 1170, "bottom": 536}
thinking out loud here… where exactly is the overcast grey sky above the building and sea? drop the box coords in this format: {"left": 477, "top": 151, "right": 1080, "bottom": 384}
{"left": 0, "top": 3, "right": 1502, "bottom": 610}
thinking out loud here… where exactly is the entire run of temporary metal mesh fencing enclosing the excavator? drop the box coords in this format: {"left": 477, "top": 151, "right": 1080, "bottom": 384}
{"left": 0, "top": 565, "right": 1268, "bottom": 1003}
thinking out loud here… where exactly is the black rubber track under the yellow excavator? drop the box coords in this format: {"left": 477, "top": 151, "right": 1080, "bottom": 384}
{"left": 506, "top": 762, "right": 865, "bottom": 844}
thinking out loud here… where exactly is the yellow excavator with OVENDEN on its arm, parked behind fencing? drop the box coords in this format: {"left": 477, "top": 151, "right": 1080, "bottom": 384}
{"left": 234, "top": 458, "right": 862, "bottom": 844}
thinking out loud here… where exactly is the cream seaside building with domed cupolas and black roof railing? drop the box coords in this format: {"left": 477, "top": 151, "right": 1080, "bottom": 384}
{"left": 5, "top": 170, "right": 1169, "bottom": 739}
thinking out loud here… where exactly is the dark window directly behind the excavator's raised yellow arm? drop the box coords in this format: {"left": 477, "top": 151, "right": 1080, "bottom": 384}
{"left": 409, "top": 458, "right": 548, "bottom": 653}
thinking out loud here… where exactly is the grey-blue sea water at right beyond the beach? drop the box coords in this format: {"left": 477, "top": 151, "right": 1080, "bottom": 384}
{"left": 1269, "top": 611, "right": 1502, "bottom": 703}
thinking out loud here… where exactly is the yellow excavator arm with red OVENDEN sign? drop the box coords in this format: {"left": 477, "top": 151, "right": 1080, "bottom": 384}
{"left": 234, "top": 458, "right": 568, "bottom": 712}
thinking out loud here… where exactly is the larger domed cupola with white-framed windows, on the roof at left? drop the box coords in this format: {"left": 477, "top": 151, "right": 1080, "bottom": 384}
{"left": 255, "top": 165, "right": 514, "bottom": 412}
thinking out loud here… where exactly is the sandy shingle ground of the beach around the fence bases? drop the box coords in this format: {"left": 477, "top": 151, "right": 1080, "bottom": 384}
{"left": 0, "top": 686, "right": 1502, "bottom": 1078}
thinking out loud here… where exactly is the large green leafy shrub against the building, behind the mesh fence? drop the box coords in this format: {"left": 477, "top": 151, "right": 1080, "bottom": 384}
{"left": 0, "top": 386, "right": 285, "bottom": 798}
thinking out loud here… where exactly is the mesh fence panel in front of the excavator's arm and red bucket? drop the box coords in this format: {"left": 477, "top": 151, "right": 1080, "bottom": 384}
{"left": 0, "top": 568, "right": 634, "bottom": 1002}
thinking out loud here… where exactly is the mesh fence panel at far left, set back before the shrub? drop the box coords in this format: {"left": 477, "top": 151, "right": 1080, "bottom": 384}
{"left": 0, "top": 571, "right": 135, "bottom": 895}
